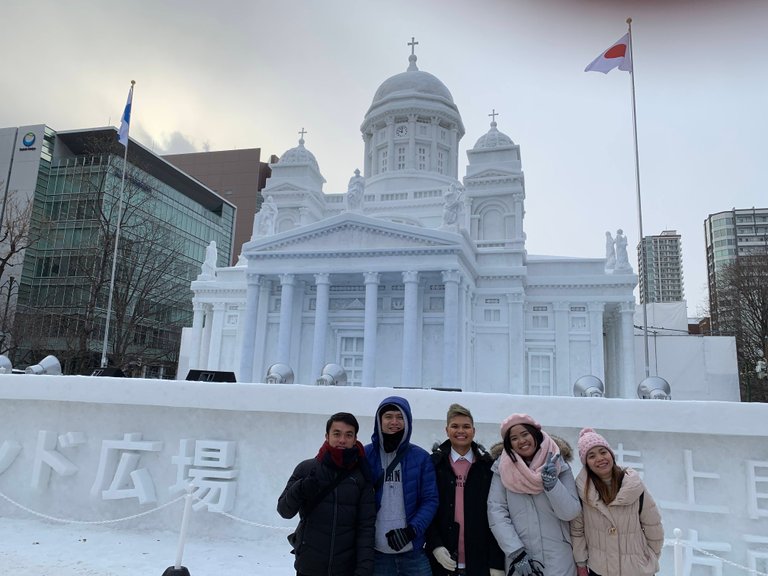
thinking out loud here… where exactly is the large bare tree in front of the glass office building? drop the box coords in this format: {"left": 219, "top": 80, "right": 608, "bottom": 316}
{"left": 12, "top": 139, "right": 195, "bottom": 373}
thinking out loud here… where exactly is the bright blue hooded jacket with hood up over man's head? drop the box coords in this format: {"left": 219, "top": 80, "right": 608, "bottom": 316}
{"left": 365, "top": 396, "right": 438, "bottom": 550}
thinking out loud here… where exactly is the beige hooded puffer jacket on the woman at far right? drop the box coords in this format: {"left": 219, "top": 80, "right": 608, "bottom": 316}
{"left": 571, "top": 467, "right": 664, "bottom": 576}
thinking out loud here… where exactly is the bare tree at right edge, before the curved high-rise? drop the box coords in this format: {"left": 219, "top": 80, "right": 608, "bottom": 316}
{"left": 717, "top": 254, "right": 768, "bottom": 402}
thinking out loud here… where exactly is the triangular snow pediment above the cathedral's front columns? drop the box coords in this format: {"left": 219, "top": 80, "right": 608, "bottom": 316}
{"left": 243, "top": 214, "right": 458, "bottom": 254}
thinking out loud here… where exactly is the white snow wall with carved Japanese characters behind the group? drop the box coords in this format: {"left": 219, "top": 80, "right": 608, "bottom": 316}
{"left": 0, "top": 375, "right": 768, "bottom": 575}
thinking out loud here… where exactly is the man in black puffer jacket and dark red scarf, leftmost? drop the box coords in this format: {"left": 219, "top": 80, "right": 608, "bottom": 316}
{"left": 277, "top": 412, "right": 376, "bottom": 576}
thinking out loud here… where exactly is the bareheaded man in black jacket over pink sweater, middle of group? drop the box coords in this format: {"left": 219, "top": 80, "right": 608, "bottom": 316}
{"left": 427, "top": 404, "right": 504, "bottom": 576}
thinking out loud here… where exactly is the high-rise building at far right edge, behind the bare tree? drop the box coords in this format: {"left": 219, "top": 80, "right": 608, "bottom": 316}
{"left": 704, "top": 208, "right": 768, "bottom": 334}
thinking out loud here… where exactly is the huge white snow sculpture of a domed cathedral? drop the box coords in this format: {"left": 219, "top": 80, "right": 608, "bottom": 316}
{"left": 179, "top": 46, "right": 637, "bottom": 398}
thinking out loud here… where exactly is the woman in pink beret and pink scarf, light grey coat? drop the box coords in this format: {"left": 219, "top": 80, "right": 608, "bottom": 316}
{"left": 488, "top": 414, "right": 581, "bottom": 576}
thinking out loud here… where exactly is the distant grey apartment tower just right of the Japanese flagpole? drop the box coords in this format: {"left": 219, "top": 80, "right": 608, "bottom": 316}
{"left": 637, "top": 230, "right": 685, "bottom": 303}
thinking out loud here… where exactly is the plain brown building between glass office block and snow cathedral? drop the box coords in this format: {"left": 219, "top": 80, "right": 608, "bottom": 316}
{"left": 163, "top": 148, "right": 278, "bottom": 264}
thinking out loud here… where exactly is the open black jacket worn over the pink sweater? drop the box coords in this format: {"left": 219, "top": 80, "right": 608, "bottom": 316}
{"left": 427, "top": 440, "right": 504, "bottom": 576}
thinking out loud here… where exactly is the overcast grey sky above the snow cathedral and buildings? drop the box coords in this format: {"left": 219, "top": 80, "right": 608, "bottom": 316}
{"left": 0, "top": 0, "right": 768, "bottom": 315}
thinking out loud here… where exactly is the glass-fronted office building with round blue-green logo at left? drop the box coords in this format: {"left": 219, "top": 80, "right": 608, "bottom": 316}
{"left": 0, "top": 124, "right": 236, "bottom": 377}
